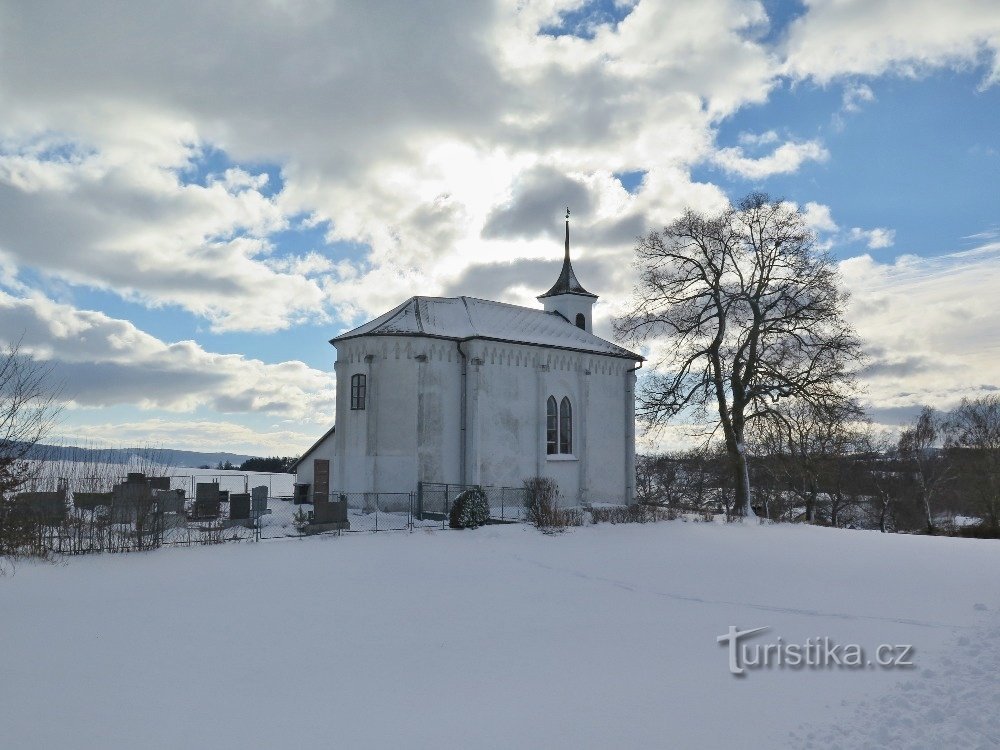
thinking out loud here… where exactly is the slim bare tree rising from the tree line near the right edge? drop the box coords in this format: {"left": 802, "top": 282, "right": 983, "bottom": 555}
{"left": 898, "top": 406, "right": 954, "bottom": 534}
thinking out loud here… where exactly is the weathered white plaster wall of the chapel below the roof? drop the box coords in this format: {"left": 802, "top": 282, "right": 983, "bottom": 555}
{"left": 332, "top": 336, "right": 634, "bottom": 505}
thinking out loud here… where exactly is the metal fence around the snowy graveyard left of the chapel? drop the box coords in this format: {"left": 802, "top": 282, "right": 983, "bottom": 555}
{"left": 0, "top": 474, "right": 526, "bottom": 555}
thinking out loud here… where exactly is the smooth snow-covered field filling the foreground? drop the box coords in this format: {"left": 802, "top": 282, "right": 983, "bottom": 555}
{"left": 0, "top": 521, "right": 1000, "bottom": 750}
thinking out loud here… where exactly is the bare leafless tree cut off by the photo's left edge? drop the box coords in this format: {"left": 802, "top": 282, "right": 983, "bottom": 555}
{"left": 0, "top": 340, "right": 62, "bottom": 498}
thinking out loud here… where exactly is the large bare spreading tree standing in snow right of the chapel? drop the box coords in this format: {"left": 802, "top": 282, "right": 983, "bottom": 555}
{"left": 615, "top": 193, "right": 860, "bottom": 515}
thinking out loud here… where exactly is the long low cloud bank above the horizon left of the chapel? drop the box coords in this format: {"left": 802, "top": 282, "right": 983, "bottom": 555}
{"left": 0, "top": 292, "right": 334, "bottom": 424}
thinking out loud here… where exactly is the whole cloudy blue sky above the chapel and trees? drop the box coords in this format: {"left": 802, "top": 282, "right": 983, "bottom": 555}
{"left": 0, "top": 0, "right": 1000, "bottom": 455}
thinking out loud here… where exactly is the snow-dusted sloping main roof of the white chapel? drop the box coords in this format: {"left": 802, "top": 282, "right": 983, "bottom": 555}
{"left": 330, "top": 297, "right": 642, "bottom": 361}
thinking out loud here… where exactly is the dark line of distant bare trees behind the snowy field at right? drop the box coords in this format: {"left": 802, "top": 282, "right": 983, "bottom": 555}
{"left": 636, "top": 395, "right": 1000, "bottom": 538}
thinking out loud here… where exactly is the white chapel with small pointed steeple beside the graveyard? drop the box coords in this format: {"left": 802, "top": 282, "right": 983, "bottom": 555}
{"left": 296, "top": 212, "right": 642, "bottom": 505}
